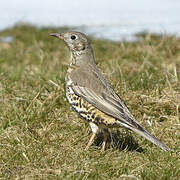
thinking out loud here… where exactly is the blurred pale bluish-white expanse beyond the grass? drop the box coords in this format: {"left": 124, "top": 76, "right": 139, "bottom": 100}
{"left": 0, "top": 0, "right": 180, "bottom": 41}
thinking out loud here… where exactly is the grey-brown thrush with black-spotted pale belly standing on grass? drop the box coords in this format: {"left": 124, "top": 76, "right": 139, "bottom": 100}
{"left": 50, "top": 31, "right": 170, "bottom": 151}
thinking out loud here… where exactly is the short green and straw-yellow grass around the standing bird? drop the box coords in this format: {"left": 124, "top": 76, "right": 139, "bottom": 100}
{"left": 0, "top": 25, "right": 180, "bottom": 180}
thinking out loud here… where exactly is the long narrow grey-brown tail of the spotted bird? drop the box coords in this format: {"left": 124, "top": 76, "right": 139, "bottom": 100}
{"left": 119, "top": 122, "right": 170, "bottom": 151}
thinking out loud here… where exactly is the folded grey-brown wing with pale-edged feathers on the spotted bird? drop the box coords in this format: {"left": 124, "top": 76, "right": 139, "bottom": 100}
{"left": 72, "top": 85, "right": 142, "bottom": 129}
